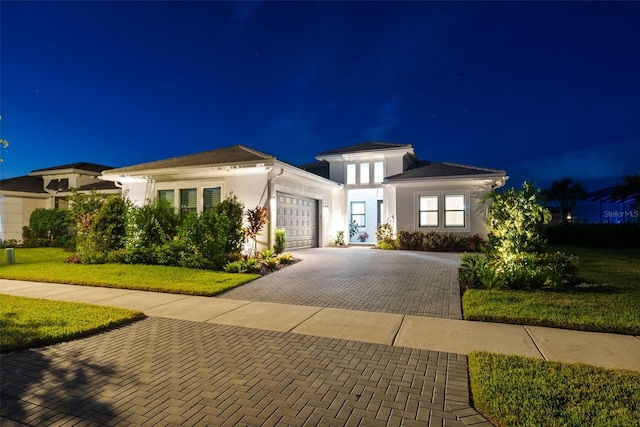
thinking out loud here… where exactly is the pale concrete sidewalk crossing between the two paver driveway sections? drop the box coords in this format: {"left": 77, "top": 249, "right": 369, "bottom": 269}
{"left": 0, "top": 279, "right": 640, "bottom": 371}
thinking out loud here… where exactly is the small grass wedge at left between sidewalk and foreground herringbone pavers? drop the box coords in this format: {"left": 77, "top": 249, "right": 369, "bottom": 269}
{"left": 0, "top": 295, "right": 144, "bottom": 353}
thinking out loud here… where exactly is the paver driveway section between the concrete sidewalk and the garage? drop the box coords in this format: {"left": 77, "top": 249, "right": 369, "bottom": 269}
{"left": 220, "top": 247, "right": 462, "bottom": 319}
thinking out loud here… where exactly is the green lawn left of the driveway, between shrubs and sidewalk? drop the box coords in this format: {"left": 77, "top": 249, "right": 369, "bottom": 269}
{"left": 0, "top": 248, "right": 260, "bottom": 296}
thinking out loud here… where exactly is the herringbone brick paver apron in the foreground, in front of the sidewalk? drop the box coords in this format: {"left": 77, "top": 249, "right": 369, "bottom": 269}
{"left": 0, "top": 318, "right": 489, "bottom": 427}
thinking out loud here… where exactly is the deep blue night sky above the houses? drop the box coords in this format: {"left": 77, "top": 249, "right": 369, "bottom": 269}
{"left": 0, "top": 1, "right": 640, "bottom": 190}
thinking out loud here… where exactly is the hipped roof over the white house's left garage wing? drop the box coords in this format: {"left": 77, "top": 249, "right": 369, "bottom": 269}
{"left": 109, "top": 145, "right": 275, "bottom": 174}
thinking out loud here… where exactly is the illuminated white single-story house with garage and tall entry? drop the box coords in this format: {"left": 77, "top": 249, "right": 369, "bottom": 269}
{"left": 102, "top": 142, "right": 507, "bottom": 249}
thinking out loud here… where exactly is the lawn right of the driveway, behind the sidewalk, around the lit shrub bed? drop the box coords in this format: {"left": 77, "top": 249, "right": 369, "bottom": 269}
{"left": 462, "top": 247, "right": 640, "bottom": 335}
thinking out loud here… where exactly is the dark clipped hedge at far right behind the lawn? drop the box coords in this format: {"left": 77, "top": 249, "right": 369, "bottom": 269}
{"left": 546, "top": 223, "right": 640, "bottom": 248}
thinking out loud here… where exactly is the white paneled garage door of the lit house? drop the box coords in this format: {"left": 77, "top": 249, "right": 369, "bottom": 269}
{"left": 277, "top": 192, "right": 318, "bottom": 249}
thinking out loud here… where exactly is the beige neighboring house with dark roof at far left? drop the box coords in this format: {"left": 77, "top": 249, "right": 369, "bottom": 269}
{"left": 0, "top": 162, "right": 121, "bottom": 241}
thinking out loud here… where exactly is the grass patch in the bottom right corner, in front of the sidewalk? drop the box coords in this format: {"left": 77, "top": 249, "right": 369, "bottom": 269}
{"left": 469, "top": 352, "right": 640, "bottom": 427}
